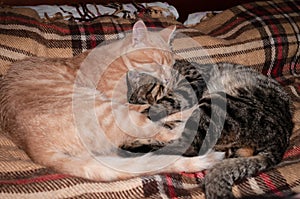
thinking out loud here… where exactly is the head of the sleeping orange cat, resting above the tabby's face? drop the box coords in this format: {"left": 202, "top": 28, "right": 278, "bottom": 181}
{"left": 122, "top": 20, "right": 176, "bottom": 82}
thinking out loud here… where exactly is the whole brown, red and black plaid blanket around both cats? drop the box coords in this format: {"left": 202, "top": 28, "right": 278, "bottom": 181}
{"left": 0, "top": 0, "right": 300, "bottom": 199}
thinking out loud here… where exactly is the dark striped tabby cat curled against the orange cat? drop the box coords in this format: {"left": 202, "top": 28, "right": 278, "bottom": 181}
{"left": 123, "top": 61, "right": 293, "bottom": 199}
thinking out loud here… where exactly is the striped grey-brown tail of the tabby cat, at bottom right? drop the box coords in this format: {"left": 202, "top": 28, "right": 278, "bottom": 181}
{"left": 204, "top": 150, "right": 283, "bottom": 199}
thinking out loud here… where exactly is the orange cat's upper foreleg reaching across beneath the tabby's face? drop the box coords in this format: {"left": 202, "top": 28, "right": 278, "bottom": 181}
{"left": 89, "top": 95, "right": 182, "bottom": 147}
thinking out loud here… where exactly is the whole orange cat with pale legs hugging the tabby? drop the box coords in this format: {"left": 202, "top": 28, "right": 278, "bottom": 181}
{"left": 0, "top": 21, "right": 223, "bottom": 181}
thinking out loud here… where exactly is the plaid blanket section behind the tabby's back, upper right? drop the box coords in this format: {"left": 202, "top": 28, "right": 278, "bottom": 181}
{"left": 174, "top": 0, "right": 300, "bottom": 94}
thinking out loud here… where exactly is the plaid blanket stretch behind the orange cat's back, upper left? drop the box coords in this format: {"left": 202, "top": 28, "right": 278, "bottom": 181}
{"left": 0, "top": 8, "right": 180, "bottom": 74}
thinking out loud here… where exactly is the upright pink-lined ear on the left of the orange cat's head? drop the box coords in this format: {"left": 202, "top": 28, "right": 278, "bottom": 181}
{"left": 132, "top": 20, "right": 148, "bottom": 46}
